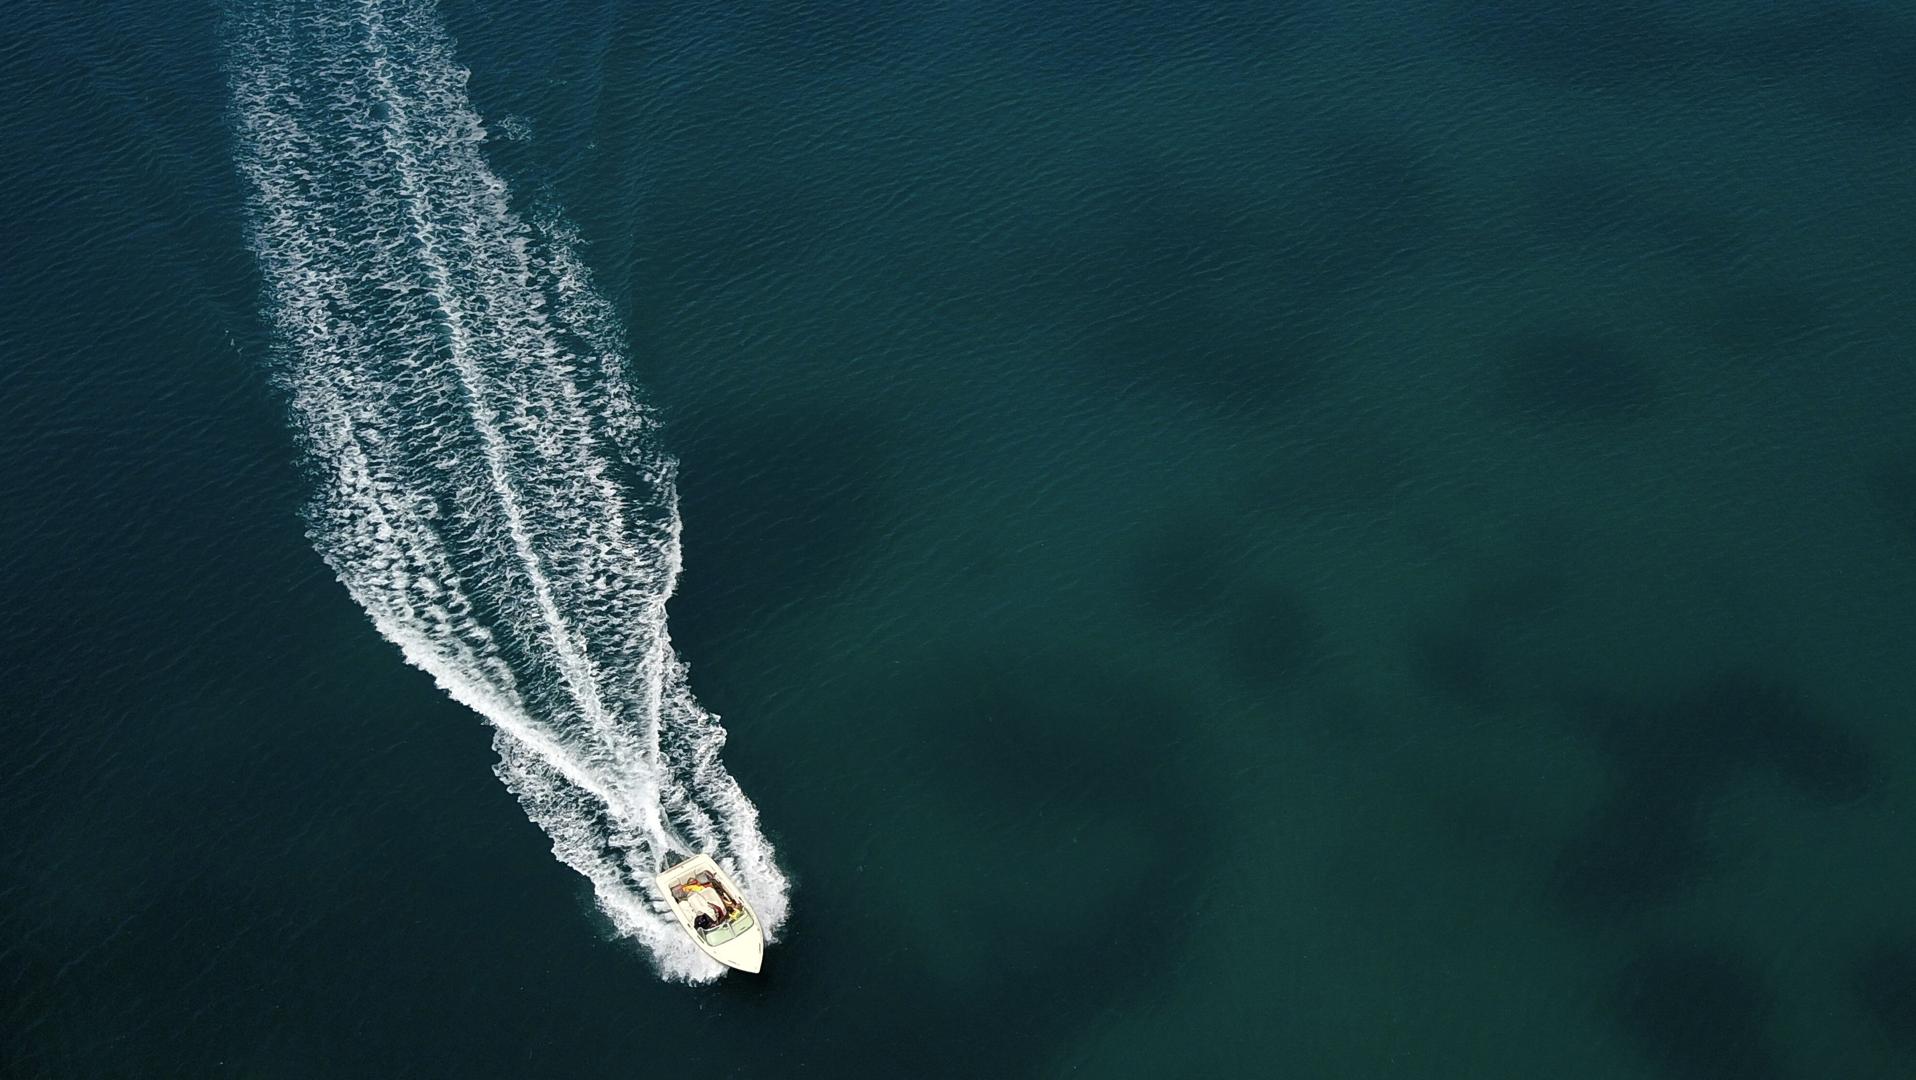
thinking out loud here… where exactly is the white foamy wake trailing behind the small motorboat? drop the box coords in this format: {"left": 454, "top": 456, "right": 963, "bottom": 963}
{"left": 228, "top": 0, "right": 786, "bottom": 980}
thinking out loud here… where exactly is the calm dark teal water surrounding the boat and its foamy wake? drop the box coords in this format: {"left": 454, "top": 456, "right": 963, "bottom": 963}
{"left": 0, "top": 0, "right": 1916, "bottom": 1078}
